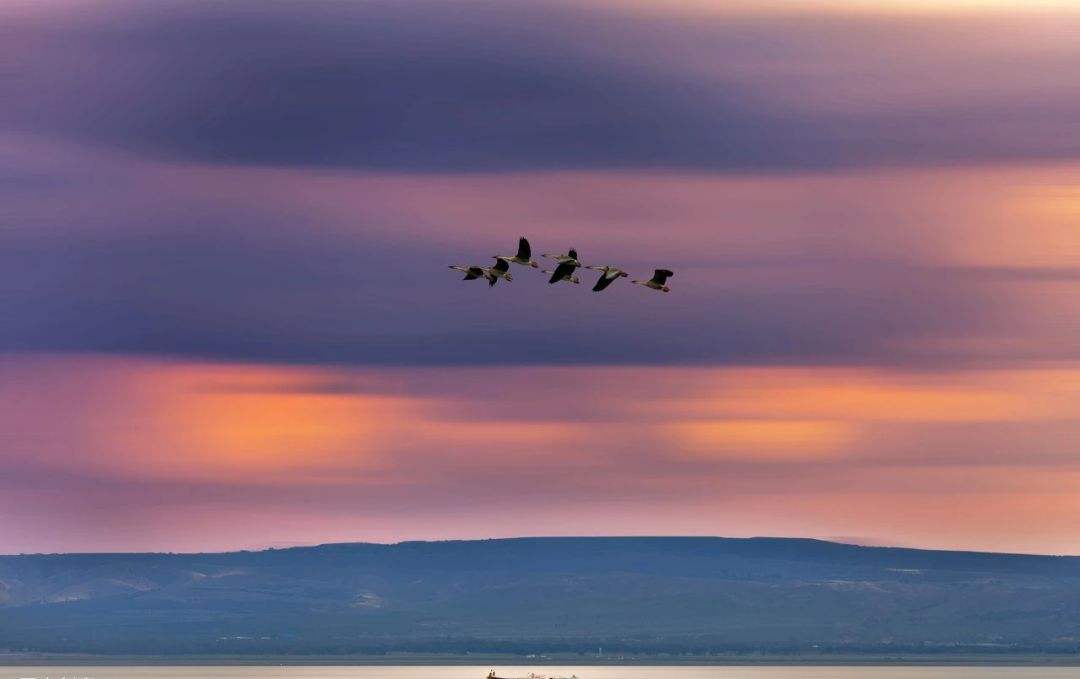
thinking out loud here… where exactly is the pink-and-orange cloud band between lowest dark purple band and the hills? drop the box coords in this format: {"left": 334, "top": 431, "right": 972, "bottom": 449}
{"left": 0, "top": 356, "right": 1080, "bottom": 552}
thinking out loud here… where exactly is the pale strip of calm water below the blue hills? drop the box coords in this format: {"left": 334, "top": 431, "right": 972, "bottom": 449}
{"left": 0, "top": 666, "right": 1080, "bottom": 679}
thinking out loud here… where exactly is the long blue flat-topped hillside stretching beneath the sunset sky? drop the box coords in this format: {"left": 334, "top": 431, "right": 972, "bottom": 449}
{"left": 0, "top": 538, "right": 1080, "bottom": 653}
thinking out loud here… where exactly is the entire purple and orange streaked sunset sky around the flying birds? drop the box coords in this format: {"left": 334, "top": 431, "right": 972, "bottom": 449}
{"left": 0, "top": 0, "right": 1080, "bottom": 555}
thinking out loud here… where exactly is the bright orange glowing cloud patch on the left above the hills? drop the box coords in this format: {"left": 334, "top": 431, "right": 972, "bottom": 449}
{"left": 71, "top": 362, "right": 421, "bottom": 484}
